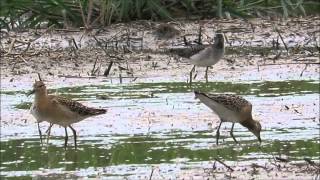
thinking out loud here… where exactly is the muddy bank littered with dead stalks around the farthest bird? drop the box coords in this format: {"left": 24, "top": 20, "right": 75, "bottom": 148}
{"left": 1, "top": 17, "right": 320, "bottom": 90}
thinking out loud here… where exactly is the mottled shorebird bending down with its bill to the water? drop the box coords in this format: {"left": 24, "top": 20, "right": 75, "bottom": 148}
{"left": 194, "top": 91, "right": 261, "bottom": 145}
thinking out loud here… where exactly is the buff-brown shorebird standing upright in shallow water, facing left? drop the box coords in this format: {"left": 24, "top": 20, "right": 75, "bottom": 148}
{"left": 29, "top": 81, "right": 106, "bottom": 148}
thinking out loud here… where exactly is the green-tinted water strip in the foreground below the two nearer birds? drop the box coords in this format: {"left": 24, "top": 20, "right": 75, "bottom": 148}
{"left": 0, "top": 136, "right": 319, "bottom": 172}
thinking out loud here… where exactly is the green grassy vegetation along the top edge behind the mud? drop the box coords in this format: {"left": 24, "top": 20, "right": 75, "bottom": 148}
{"left": 0, "top": 0, "right": 320, "bottom": 29}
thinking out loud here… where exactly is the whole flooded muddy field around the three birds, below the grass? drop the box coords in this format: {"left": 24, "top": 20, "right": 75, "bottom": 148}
{"left": 0, "top": 17, "right": 320, "bottom": 180}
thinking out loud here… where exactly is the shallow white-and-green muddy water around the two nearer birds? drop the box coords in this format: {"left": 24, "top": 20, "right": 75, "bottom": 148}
{"left": 0, "top": 80, "right": 320, "bottom": 179}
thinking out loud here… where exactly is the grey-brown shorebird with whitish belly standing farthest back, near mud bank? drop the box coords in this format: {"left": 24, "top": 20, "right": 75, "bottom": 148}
{"left": 169, "top": 32, "right": 224, "bottom": 84}
